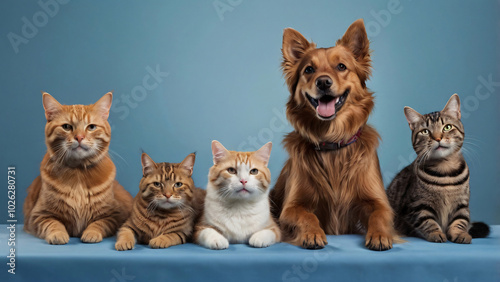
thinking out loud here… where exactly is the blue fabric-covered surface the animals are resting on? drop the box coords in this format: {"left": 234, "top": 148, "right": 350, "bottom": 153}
{"left": 0, "top": 224, "right": 500, "bottom": 282}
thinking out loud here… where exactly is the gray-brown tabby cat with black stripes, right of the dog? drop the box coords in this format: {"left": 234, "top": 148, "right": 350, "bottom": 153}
{"left": 387, "top": 94, "right": 489, "bottom": 244}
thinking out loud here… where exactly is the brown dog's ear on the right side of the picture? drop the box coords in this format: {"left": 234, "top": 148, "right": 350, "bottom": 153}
{"left": 337, "top": 19, "right": 370, "bottom": 61}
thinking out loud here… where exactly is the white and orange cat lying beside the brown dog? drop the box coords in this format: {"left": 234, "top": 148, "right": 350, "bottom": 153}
{"left": 194, "top": 141, "right": 281, "bottom": 250}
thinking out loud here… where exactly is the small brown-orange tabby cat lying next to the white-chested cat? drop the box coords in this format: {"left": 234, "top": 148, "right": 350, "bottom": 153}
{"left": 115, "top": 153, "right": 205, "bottom": 251}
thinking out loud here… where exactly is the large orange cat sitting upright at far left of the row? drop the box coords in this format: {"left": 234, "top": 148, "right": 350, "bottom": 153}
{"left": 24, "top": 92, "right": 132, "bottom": 245}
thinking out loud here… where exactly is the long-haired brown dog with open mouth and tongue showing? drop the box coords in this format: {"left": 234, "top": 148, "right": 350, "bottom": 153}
{"left": 271, "top": 19, "right": 394, "bottom": 251}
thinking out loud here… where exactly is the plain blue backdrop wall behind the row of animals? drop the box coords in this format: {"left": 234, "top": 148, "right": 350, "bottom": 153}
{"left": 0, "top": 0, "right": 500, "bottom": 224}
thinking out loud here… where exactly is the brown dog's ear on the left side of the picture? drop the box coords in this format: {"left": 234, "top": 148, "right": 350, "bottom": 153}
{"left": 281, "top": 28, "right": 314, "bottom": 65}
